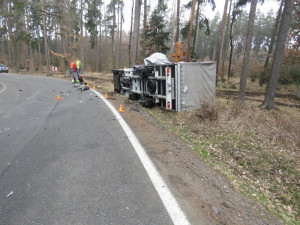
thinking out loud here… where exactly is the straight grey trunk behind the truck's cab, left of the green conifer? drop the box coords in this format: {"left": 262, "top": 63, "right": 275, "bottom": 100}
{"left": 131, "top": 0, "right": 142, "bottom": 66}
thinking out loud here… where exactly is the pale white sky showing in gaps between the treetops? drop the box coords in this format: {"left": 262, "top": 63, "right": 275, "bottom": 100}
{"left": 120, "top": 0, "right": 279, "bottom": 31}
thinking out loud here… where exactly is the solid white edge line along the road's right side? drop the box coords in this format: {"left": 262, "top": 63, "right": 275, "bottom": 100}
{"left": 91, "top": 89, "right": 190, "bottom": 225}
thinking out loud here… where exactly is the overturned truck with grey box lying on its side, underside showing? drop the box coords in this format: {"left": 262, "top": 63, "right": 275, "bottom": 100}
{"left": 112, "top": 62, "right": 216, "bottom": 112}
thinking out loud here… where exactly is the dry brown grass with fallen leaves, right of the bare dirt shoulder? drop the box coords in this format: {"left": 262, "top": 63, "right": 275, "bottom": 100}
{"left": 148, "top": 99, "right": 300, "bottom": 224}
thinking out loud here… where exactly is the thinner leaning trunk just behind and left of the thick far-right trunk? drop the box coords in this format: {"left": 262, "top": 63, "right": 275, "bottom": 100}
{"left": 259, "top": 0, "right": 284, "bottom": 87}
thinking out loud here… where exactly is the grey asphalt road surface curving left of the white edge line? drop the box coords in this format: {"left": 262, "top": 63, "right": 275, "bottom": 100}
{"left": 0, "top": 74, "right": 172, "bottom": 225}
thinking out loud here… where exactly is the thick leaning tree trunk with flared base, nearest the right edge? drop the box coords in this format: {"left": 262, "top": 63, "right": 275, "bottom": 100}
{"left": 261, "top": 0, "right": 294, "bottom": 109}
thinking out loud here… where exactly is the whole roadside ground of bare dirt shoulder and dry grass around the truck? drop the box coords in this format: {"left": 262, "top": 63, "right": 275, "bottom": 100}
{"left": 19, "top": 73, "right": 300, "bottom": 224}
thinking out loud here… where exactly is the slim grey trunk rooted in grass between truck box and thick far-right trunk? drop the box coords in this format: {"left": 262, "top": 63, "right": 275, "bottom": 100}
{"left": 239, "top": 0, "right": 257, "bottom": 104}
